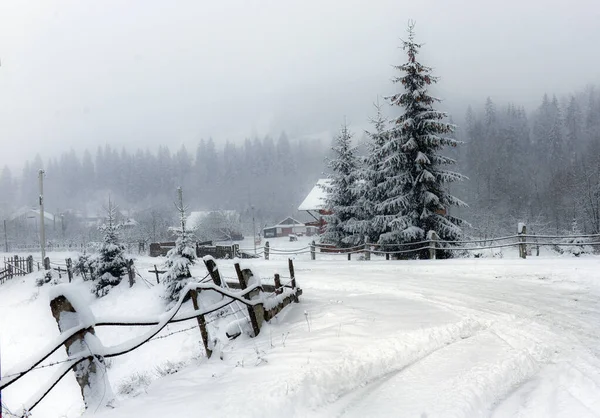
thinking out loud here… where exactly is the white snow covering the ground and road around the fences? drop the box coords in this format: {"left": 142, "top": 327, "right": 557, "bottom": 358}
{"left": 0, "top": 239, "right": 600, "bottom": 418}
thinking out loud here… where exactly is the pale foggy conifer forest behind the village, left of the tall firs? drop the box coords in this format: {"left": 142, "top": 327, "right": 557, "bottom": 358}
{"left": 0, "top": 133, "right": 325, "bottom": 225}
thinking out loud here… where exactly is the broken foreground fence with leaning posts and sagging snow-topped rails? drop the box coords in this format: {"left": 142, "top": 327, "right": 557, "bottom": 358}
{"left": 0, "top": 258, "right": 302, "bottom": 417}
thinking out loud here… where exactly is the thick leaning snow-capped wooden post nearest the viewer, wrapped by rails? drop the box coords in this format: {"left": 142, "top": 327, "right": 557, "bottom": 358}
{"left": 50, "top": 295, "right": 114, "bottom": 409}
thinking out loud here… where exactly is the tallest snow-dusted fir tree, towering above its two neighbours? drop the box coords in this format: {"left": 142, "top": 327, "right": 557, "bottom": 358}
{"left": 374, "top": 23, "right": 465, "bottom": 255}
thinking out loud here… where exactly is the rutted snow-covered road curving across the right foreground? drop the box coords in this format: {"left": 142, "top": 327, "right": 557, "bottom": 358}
{"left": 312, "top": 260, "right": 600, "bottom": 417}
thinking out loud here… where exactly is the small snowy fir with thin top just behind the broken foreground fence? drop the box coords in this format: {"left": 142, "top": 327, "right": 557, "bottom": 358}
{"left": 163, "top": 187, "right": 196, "bottom": 303}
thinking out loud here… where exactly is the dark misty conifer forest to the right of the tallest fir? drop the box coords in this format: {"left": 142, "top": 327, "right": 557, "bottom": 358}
{"left": 457, "top": 87, "right": 600, "bottom": 237}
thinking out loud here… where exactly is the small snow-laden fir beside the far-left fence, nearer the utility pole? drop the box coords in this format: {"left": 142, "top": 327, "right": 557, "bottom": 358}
{"left": 93, "top": 198, "right": 127, "bottom": 297}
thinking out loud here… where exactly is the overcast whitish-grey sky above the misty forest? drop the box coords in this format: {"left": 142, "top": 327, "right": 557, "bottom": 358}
{"left": 0, "top": 0, "right": 600, "bottom": 167}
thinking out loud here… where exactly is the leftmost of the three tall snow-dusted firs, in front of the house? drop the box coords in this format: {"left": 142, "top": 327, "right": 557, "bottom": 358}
{"left": 322, "top": 123, "right": 358, "bottom": 246}
